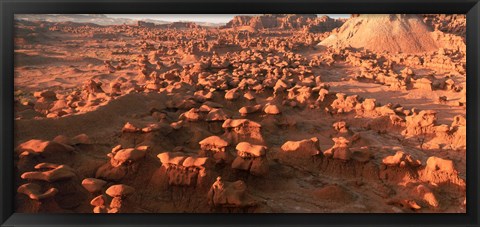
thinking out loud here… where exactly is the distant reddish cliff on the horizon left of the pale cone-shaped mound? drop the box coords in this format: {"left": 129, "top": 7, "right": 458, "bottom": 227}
{"left": 225, "top": 14, "right": 344, "bottom": 32}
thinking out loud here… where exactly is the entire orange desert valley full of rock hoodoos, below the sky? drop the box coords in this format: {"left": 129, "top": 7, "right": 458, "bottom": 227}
{"left": 11, "top": 14, "right": 464, "bottom": 214}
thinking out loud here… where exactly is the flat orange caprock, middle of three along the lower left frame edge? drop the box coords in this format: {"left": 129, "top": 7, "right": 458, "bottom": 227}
{"left": 21, "top": 163, "right": 75, "bottom": 182}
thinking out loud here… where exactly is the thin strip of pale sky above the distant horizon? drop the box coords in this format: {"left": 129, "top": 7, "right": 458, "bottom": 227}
{"left": 105, "top": 14, "right": 350, "bottom": 23}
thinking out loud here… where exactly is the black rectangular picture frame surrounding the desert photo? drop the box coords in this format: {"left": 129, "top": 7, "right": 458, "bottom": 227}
{"left": 0, "top": 0, "right": 480, "bottom": 226}
